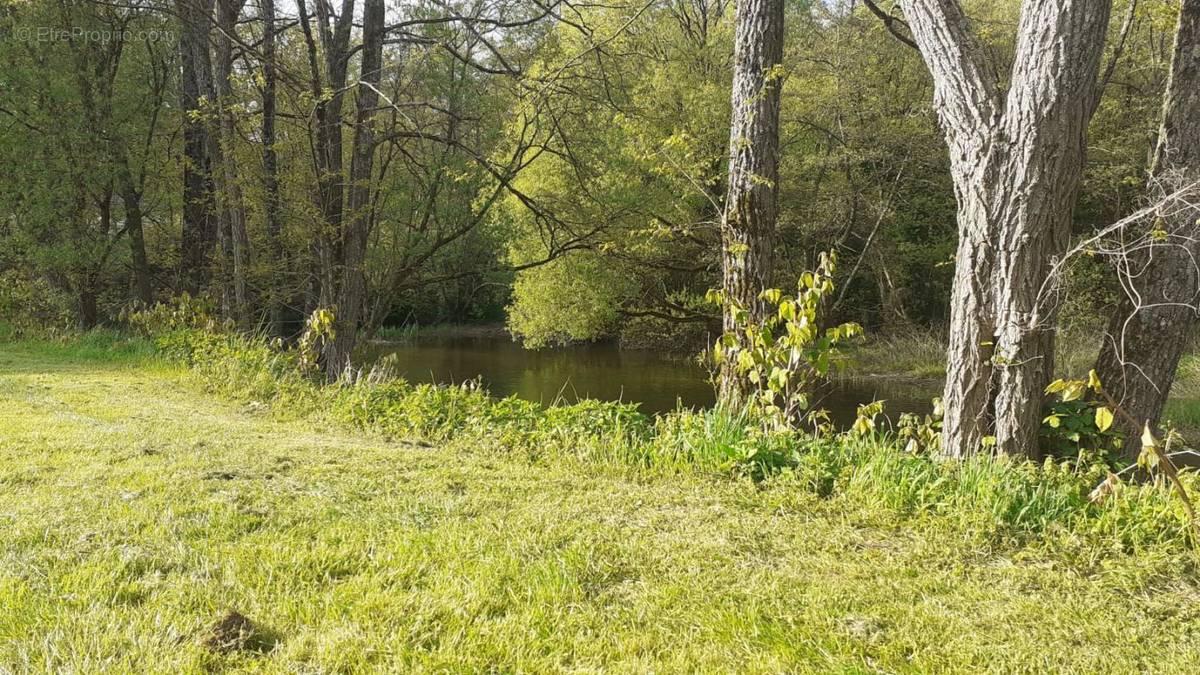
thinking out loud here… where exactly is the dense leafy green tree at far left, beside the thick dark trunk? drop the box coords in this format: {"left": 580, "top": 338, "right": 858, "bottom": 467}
{"left": 0, "top": 2, "right": 170, "bottom": 328}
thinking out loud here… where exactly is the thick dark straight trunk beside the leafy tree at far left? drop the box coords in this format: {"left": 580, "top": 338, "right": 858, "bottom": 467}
{"left": 175, "top": 0, "right": 216, "bottom": 293}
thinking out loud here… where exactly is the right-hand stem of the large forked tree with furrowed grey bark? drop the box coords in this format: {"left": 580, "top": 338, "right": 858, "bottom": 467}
{"left": 992, "top": 0, "right": 1112, "bottom": 458}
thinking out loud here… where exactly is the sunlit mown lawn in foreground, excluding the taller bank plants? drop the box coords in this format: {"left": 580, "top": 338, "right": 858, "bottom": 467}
{"left": 0, "top": 345, "right": 1200, "bottom": 673}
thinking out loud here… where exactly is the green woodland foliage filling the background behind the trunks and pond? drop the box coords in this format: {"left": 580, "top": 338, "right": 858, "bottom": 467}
{"left": 0, "top": 0, "right": 1175, "bottom": 345}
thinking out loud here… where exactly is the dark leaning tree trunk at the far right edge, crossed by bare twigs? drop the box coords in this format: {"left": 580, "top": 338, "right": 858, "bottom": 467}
{"left": 1096, "top": 0, "right": 1200, "bottom": 459}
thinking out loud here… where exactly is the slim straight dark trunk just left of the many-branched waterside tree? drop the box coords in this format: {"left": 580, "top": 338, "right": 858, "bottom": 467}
{"left": 262, "top": 0, "right": 286, "bottom": 335}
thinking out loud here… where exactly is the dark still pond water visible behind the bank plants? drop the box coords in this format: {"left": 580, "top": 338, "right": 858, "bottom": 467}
{"left": 360, "top": 336, "right": 937, "bottom": 424}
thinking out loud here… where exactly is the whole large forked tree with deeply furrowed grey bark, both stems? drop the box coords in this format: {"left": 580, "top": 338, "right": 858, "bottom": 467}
{"left": 901, "top": 0, "right": 1111, "bottom": 456}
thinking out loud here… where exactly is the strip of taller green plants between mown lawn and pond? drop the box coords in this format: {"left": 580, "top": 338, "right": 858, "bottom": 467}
{"left": 129, "top": 329, "right": 1200, "bottom": 562}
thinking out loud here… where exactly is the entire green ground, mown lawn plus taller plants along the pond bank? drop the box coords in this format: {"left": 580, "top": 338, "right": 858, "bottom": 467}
{"left": 7, "top": 329, "right": 1200, "bottom": 671}
